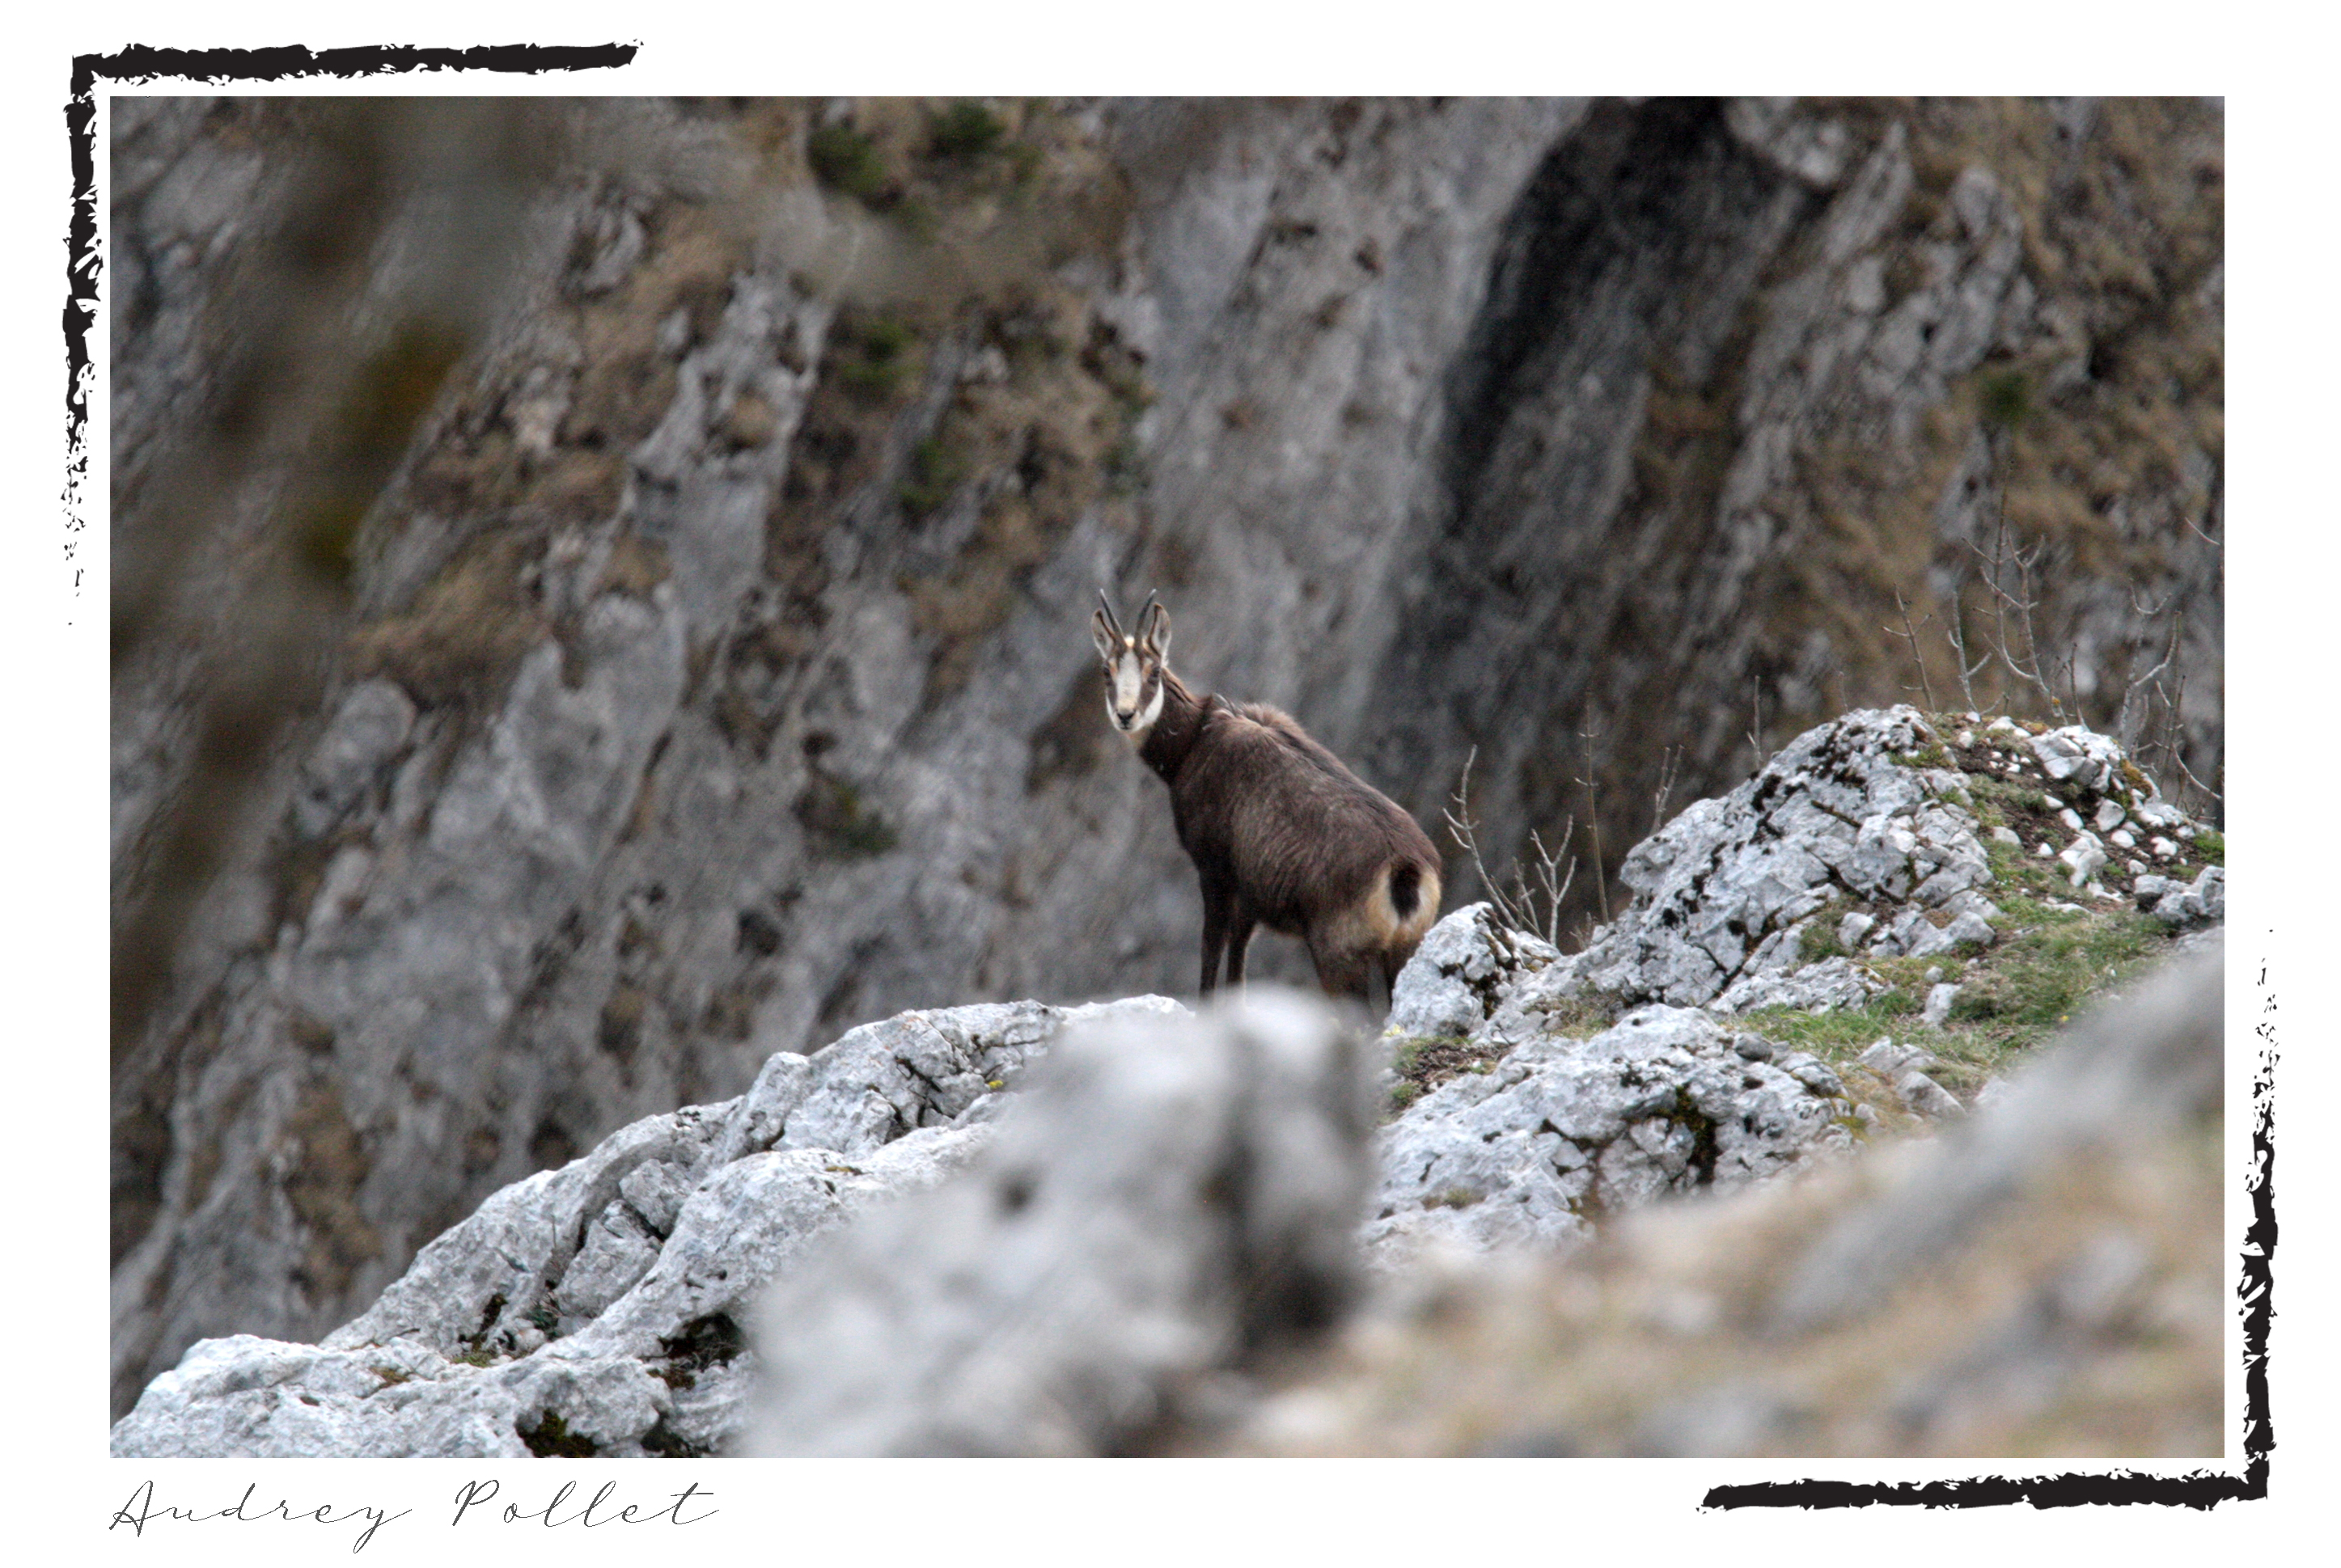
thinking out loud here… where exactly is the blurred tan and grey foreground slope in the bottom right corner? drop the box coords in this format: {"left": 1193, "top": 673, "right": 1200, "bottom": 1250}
{"left": 1217, "top": 936, "right": 2233, "bottom": 1474}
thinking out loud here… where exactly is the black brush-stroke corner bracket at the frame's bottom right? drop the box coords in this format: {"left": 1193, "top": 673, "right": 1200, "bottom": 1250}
{"left": 1700, "top": 960, "right": 2278, "bottom": 1512}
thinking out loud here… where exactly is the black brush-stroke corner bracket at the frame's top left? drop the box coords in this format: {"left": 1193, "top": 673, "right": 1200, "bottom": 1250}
{"left": 63, "top": 42, "right": 641, "bottom": 613}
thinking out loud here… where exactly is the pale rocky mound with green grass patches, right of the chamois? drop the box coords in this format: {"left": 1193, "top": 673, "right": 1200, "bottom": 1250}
{"left": 1367, "top": 707, "right": 2226, "bottom": 1259}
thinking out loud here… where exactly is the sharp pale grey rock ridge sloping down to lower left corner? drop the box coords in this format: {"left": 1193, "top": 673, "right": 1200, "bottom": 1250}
{"left": 112, "top": 997, "right": 1184, "bottom": 1458}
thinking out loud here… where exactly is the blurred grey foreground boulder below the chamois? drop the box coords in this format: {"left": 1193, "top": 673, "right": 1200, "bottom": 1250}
{"left": 751, "top": 990, "right": 1372, "bottom": 1453}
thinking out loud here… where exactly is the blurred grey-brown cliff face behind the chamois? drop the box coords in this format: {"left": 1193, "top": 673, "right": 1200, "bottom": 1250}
{"left": 112, "top": 100, "right": 2224, "bottom": 1409}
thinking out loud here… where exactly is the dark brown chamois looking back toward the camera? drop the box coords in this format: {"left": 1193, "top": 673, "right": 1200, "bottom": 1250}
{"left": 1091, "top": 592, "right": 1440, "bottom": 1002}
